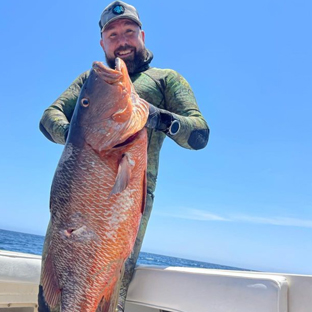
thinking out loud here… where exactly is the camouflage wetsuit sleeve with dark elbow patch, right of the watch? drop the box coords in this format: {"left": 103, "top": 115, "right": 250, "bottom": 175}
{"left": 165, "top": 71, "right": 209, "bottom": 150}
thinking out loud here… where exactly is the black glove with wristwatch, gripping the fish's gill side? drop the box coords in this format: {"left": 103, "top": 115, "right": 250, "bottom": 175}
{"left": 145, "top": 104, "right": 180, "bottom": 135}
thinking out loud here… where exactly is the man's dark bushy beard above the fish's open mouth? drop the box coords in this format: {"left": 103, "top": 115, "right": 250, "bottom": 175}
{"left": 105, "top": 44, "right": 148, "bottom": 74}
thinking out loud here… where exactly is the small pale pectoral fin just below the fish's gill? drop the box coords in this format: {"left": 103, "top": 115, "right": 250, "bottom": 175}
{"left": 110, "top": 154, "right": 133, "bottom": 195}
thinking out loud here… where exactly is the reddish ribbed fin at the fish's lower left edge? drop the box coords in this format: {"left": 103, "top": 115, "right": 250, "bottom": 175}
{"left": 41, "top": 253, "right": 61, "bottom": 308}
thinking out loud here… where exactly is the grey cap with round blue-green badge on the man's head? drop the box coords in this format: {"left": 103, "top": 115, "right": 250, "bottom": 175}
{"left": 99, "top": 1, "right": 142, "bottom": 32}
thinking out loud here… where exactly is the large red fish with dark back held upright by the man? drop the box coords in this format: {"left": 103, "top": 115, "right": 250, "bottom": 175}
{"left": 39, "top": 58, "right": 148, "bottom": 312}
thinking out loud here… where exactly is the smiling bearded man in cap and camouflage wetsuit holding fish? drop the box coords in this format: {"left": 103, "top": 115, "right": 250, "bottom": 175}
{"left": 39, "top": 1, "right": 209, "bottom": 311}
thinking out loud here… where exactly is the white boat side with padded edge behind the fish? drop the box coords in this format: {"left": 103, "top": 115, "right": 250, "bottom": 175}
{"left": 0, "top": 251, "right": 312, "bottom": 312}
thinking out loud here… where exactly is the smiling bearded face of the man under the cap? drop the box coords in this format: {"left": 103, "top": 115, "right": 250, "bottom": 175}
{"left": 100, "top": 19, "right": 147, "bottom": 73}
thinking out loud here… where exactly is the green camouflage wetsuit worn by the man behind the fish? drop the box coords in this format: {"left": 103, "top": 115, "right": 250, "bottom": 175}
{"left": 39, "top": 53, "right": 209, "bottom": 311}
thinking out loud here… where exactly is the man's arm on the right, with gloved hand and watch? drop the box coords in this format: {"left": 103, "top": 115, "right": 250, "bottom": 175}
{"left": 146, "top": 71, "right": 209, "bottom": 150}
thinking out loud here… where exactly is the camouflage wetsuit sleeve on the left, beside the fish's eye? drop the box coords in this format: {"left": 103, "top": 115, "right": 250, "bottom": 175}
{"left": 39, "top": 71, "right": 89, "bottom": 144}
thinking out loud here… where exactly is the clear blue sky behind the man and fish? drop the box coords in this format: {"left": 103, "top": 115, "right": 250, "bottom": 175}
{"left": 0, "top": 0, "right": 312, "bottom": 274}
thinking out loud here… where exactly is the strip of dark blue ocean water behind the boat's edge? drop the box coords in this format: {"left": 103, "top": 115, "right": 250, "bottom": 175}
{"left": 0, "top": 229, "right": 248, "bottom": 271}
